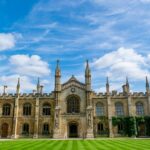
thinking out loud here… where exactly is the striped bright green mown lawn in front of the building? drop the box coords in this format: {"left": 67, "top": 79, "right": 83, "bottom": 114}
{"left": 0, "top": 139, "right": 150, "bottom": 150}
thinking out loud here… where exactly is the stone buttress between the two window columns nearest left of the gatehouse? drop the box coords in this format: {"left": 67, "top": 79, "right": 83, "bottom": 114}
{"left": 33, "top": 97, "right": 40, "bottom": 138}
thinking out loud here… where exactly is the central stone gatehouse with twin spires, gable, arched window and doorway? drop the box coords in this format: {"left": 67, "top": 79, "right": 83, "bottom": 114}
{"left": 53, "top": 61, "right": 94, "bottom": 138}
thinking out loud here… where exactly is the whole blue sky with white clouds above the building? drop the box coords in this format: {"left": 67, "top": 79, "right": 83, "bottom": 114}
{"left": 0, "top": 0, "right": 150, "bottom": 92}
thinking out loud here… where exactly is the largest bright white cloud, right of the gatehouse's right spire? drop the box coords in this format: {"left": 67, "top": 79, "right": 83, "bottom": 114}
{"left": 91, "top": 47, "right": 150, "bottom": 80}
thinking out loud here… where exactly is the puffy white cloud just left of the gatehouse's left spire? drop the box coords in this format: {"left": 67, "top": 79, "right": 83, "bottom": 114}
{"left": 9, "top": 55, "right": 50, "bottom": 77}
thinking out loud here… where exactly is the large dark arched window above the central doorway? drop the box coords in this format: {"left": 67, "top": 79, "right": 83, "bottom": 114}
{"left": 67, "top": 96, "right": 80, "bottom": 113}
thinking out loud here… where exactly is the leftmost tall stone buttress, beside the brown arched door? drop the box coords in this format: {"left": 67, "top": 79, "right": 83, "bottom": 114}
{"left": 12, "top": 95, "right": 19, "bottom": 139}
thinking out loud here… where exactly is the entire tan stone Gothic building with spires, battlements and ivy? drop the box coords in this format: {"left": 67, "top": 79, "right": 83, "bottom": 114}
{"left": 0, "top": 61, "right": 150, "bottom": 139}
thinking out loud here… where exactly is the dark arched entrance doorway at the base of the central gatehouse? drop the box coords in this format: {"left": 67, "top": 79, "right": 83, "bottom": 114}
{"left": 68, "top": 122, "right": 78, "bottom": 138}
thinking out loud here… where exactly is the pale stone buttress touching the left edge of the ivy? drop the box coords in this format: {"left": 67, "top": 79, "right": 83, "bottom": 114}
{"left": 107, "top": 95, "right": 114, "bottom": 137}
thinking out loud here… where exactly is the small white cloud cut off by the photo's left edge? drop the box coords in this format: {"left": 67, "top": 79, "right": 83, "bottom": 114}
{"left": 0, "top": 33, "right": 16, "bottom": 51}
